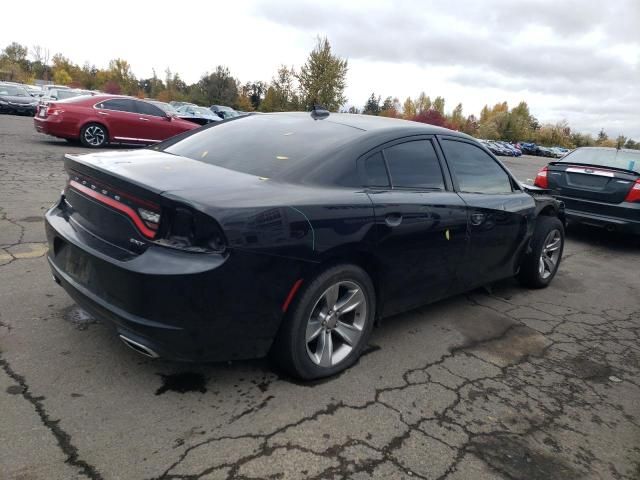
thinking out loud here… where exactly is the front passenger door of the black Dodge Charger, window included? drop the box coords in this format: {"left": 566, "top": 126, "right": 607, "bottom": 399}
{"left": 439, "top": 137, "right": 535, "bottom": 288}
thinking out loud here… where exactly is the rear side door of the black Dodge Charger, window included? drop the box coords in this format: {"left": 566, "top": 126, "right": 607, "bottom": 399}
{"left": 368, "top": 137, "right": 467, "bottom": 315}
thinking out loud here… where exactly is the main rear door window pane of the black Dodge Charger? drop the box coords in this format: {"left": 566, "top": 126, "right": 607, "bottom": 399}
{"left": 384, "top": 140, "right": 444, "bottom": 190}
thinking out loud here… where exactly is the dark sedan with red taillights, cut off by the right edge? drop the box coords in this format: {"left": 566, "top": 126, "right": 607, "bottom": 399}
{"left": 535, "top": 147, "right": 640, "bottom": 235}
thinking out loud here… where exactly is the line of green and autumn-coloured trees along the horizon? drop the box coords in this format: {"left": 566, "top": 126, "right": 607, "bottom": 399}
{"left": 0, "top": 38, "right": 640, "bottom": 149}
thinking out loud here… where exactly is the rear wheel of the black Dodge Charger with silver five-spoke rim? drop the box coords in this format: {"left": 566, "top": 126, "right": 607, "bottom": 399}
{"left": 271, "top": 264, "right": 376, "bottom": 380}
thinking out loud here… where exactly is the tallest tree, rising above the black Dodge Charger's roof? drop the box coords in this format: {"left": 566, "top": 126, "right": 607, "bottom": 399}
{"left": 298, "top": 37, "right": 348, "bottom": 112}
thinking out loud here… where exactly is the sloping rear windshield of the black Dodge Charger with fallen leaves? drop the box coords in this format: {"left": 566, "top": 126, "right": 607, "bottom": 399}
{"left": 165, "top": 114, "right": 362, "bottom": 178}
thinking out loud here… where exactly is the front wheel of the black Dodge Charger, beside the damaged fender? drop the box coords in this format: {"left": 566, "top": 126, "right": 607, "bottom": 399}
{"left": 517, "top": 216, "right": 564, "bottom": 288}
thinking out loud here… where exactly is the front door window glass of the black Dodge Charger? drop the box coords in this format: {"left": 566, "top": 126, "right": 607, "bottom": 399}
{"left": 442, "top": 140, "right": 513, "bottom": 194}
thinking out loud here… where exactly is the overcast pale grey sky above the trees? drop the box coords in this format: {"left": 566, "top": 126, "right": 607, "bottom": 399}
{"left": 0, "top": 0, "right": 640, "bottom": 139}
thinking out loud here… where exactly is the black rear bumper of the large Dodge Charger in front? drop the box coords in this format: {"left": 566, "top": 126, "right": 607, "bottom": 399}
{"left": 45, "top": 198, "right": 304, "bottom": 361}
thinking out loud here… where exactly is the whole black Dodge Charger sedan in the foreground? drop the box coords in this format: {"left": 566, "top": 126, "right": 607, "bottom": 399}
{"left": 46, "top": 110, "right": 564, "bottom": 379}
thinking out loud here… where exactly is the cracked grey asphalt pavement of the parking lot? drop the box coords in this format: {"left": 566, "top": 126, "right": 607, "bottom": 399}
{"left": 0, "top": 116, "right": 640, "bottom": 480}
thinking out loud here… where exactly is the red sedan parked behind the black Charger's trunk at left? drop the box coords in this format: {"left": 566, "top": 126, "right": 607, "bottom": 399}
{"left": 33, "top": 95, "right": 199, "bottom": 147}
